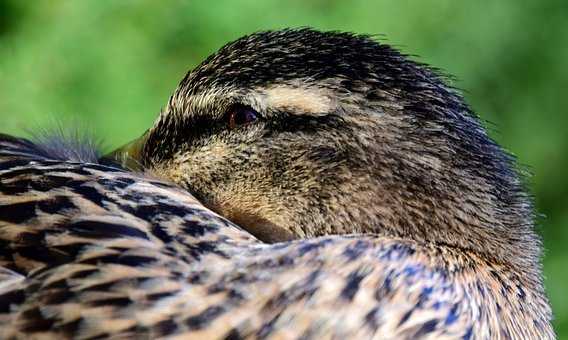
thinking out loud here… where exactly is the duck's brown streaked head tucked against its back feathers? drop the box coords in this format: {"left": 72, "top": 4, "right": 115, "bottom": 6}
{"left": 107, "top": 29, "right": 540, "bottom": 274}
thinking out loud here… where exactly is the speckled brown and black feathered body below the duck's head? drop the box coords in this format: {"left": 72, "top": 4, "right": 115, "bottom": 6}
{"left": 0, "top": 137, "right": 554, "bottom": 339}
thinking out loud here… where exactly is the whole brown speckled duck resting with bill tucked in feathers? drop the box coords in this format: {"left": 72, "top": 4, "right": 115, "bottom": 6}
{"left": 0, "top": 29, "right": 554, "bottom": 339}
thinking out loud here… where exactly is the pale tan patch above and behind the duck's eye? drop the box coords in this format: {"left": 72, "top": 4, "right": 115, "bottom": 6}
{"left": 262, "top": 86, "right": 336, "bottom": 116}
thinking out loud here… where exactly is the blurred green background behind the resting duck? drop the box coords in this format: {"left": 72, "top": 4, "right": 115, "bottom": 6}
{"left": 0, "top": 0, "right": 568, "bottom": 338}
